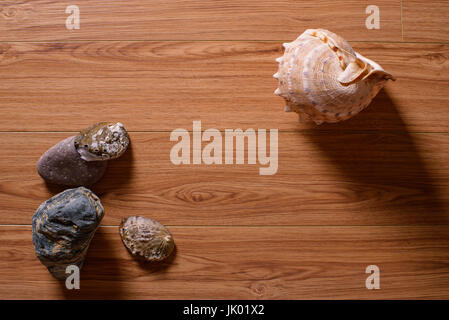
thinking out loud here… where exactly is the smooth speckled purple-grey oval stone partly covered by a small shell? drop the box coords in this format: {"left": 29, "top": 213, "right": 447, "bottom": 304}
{"left": 37, "top": 136, "right": 107, "bottom": 187}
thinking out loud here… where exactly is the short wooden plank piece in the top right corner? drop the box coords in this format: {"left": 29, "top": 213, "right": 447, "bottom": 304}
{"left": 402, "top": 0, "right": 449, "bottom": 43}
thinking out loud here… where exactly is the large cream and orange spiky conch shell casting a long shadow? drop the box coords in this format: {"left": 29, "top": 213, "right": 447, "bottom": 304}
{"left": 273, "top": 29, "right": 395, "bottom": 124}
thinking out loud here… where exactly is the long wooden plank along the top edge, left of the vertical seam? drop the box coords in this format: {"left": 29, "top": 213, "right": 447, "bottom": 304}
{"left": 0, "top": 0, "right": 401, "bottom": 41}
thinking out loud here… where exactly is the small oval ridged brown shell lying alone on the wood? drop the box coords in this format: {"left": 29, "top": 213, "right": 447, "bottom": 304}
{"left": 119, "top": 216, "right": 175, "bottom": 261}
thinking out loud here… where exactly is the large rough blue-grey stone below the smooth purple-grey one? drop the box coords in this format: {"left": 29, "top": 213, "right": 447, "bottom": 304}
{"left": 32, "top": 187, "right": 104, "bottom": 279}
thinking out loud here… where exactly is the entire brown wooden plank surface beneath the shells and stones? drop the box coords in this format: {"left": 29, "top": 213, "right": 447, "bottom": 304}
{"left": 0, "top": 0, "right": 449, "bottom": 299}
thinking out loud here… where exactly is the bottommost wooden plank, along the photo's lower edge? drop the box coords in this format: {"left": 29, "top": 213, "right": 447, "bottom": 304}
{"left": 0, "top": 226, "right": 449, "bottom": 299}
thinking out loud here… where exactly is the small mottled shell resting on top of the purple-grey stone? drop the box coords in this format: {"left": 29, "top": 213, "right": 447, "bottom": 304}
{"left": 75, "top": 122, "right": 129, "bottom": 161}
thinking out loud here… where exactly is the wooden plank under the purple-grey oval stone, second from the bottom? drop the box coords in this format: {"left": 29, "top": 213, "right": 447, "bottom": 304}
{"left": 0, "top": 131, "right": 449, "bottom": 226}
